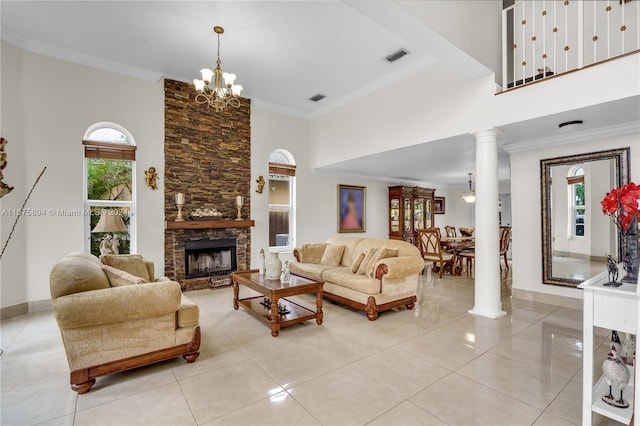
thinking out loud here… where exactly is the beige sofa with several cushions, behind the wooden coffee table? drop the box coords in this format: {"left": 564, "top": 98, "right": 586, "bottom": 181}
{"left": 291, "top": 237, "right": 424, "bottom": 321}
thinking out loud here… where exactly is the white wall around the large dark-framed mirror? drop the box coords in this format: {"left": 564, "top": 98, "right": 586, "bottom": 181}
{"left": 511, "top": 133, "right": 640, "bottom": 298}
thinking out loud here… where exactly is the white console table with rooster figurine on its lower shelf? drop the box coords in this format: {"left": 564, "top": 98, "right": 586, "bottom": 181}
{"left": 578, "top": 265, "right": 640, "bottom": 425}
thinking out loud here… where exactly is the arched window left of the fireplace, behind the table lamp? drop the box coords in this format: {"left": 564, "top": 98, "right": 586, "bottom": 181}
{"left": 82, "top": 123, "right": 136, "bottom": 256}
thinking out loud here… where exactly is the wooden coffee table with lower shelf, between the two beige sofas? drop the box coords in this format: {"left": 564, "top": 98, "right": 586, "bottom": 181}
{"left": 231, "top": 270, "right": 324, "bottom": 337}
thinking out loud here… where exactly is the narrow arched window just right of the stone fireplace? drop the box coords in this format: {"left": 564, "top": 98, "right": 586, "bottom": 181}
{"left": 269, "top": 149, "right": 296, "bottom": 251}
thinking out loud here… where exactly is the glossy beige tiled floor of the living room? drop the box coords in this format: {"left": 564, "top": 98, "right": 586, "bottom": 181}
{"left": 0, "top": 273, "right": 617, "bottom": 426}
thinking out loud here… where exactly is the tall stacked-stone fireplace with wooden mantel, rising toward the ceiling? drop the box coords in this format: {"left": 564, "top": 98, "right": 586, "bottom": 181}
{"left": 164, "top": 80, "right": 253, "bottom": 290}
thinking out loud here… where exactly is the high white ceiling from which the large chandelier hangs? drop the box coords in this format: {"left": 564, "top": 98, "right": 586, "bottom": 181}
{"left": 0, "top": 0, "right": 470, "bottom": 117}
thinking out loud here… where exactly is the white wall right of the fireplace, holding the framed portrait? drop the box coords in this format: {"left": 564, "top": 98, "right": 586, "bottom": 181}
{"left": 251, "top": 103, "right": 389, "bottom": 265}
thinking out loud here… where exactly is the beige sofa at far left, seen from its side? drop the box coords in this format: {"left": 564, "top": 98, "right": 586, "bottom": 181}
{"left": 50, "top": 253, "right": 200, "bottom": 393}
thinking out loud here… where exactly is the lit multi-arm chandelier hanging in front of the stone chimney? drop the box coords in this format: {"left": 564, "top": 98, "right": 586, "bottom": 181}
{"left": 193, "top": 26, "right": 242, "bottom": 111}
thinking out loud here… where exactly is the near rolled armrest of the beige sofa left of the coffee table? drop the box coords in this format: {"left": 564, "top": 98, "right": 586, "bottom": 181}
{"left": 53, "top": 281, "right": 182, "bottom": 329}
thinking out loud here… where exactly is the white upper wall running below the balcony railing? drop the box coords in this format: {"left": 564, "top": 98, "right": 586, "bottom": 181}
{"left": 311, "top": 54, "right": 640, "bottom": 171}
